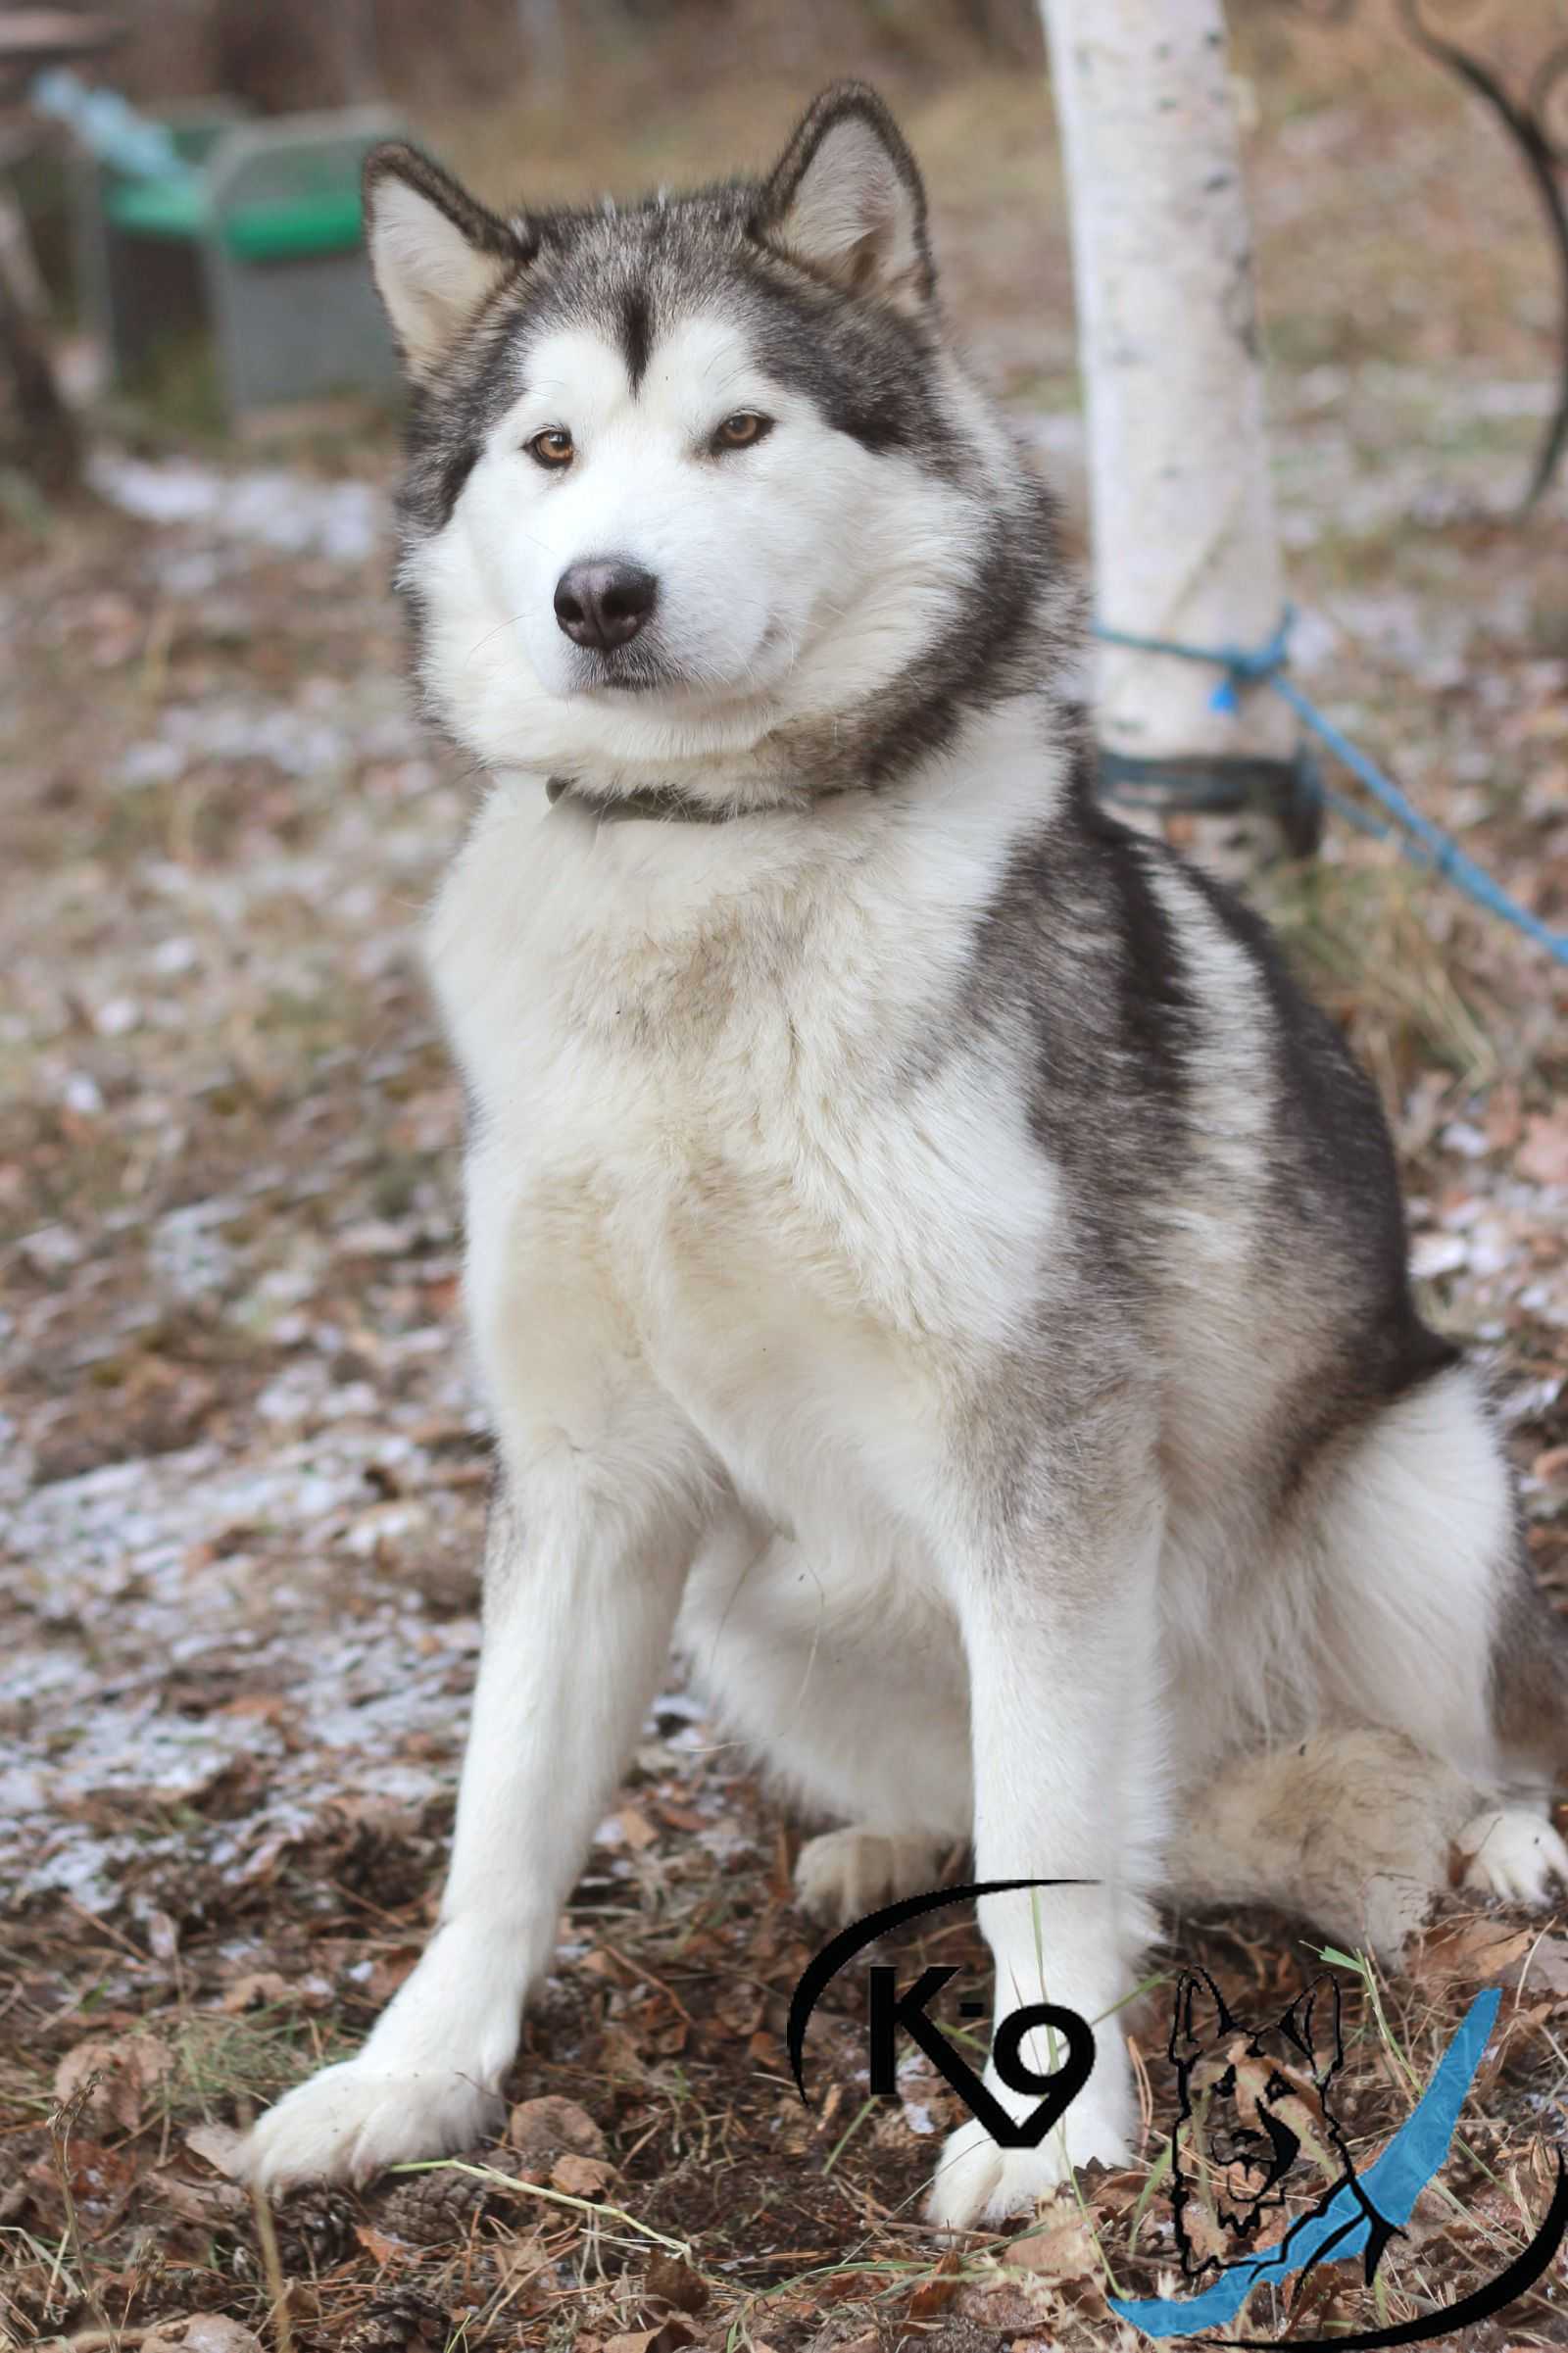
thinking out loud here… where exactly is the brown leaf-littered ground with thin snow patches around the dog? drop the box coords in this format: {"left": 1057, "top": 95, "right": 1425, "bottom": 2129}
{"left": 0, "top": 10, "right": 1568, "bottom": 2353}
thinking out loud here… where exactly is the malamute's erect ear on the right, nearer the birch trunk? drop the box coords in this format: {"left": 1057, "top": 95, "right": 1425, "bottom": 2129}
{"left": 754, "top": 82, "right": 937, "bottom": 311}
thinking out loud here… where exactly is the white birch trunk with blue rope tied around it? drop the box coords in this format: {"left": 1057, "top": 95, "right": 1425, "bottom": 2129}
{"left": 1041, "top": 0, "right": 1295, "bottom": 758}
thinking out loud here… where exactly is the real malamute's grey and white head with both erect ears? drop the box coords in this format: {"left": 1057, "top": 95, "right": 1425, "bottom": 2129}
{"left": 365, "top": 84, "right": 1054, "bottom": 791}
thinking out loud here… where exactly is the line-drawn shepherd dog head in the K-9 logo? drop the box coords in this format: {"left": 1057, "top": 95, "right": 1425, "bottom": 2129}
{"left": 1170, "top": 1970, "right": 1349, "bottom": 2276}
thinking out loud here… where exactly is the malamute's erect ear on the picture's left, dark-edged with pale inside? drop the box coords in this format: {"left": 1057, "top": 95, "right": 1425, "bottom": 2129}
{"left": 365, "top": 141, "right": 530, "bottom": 381}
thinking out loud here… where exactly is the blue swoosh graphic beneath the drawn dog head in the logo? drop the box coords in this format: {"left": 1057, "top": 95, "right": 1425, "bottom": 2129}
{"left": 1106, "top": 1985, "right": 1502, "bottom": 2341}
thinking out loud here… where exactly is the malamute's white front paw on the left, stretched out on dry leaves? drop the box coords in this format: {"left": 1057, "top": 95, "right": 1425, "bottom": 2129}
{"left": 240, "top": 2059, "right": 499, "bottom": 2190}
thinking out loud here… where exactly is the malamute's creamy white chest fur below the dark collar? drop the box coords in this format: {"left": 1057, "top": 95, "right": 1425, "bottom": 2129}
{"left": 428, "top": 720, "right": 1053, "bottom": 1524}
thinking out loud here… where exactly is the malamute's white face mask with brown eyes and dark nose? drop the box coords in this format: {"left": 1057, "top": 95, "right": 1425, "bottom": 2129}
{"left": 416, "top": 318, "right": 963, "bottom": 760}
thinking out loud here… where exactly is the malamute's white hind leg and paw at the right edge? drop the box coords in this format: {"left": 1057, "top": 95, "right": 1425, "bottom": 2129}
{"left": 1280, "top": 1365, "right": 1568, "bottom": 1903}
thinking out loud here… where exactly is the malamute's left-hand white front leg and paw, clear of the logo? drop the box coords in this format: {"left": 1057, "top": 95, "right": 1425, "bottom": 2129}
{"left": 247, "top": 1445, "right": 697, "bottom": 2186}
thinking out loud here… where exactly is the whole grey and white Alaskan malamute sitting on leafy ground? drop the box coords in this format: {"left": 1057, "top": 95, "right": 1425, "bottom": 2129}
{"left": 250, "top": 87, "right": 1568, "bottom": 2226}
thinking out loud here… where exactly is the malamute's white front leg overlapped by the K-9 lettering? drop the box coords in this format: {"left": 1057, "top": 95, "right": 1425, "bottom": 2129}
{"left": 928, "top": 1480, "right": 1160, "bottom": 2229}
